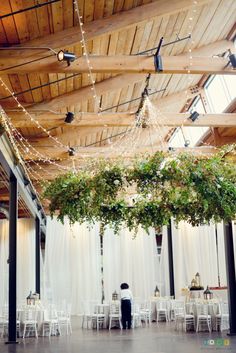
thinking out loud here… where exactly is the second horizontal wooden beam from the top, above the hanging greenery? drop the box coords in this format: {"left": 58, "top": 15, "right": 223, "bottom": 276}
{"left": 8, "top": 111, "right": 236, "bottom": 129}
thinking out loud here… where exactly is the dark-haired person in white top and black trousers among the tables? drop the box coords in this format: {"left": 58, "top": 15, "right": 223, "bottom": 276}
{"left": 120, "top": 283, "right": 133, "bottom": 330}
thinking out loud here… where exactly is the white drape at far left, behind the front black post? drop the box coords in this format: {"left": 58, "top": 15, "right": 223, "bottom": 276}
{"left": 0, "top": 219, "right": 35, "bottom": 306}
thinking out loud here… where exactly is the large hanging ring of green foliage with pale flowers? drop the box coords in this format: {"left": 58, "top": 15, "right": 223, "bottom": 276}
{"left": 44, "top": 144, "right": 236, "bottom": 232}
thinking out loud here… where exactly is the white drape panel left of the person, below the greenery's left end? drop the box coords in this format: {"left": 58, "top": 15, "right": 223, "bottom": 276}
{"left": 43, "top": 218, "right": 102, "bottom": 315}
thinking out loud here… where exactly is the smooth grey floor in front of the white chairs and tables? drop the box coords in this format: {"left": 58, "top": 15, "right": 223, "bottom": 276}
{"left": 0, "top": 318, "right": 236, "bottom": 353}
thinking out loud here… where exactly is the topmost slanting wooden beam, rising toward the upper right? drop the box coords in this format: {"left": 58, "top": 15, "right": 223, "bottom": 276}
{"left": 0, "top": 0, "right": 212, "bottom": 60}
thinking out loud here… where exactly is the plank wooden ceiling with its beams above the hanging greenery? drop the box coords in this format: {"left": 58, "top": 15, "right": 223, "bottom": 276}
{"left": 0, "top": 0, "right": 236, "bottom": 191}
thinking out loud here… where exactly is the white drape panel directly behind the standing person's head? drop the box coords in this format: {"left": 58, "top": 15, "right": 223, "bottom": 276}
{"left": 103, "top": 228, "right": 160, "bottom": 302}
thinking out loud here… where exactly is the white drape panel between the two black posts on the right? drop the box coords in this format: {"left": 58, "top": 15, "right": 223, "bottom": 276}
{"left": 172, "top": 222, "right": 218, "bottom": 297}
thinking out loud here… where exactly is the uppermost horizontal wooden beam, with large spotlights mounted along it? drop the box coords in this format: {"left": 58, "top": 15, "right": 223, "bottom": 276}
{"left": 1, "top": 55, "right": 236, "bottom": 75}
